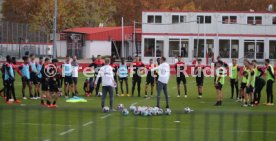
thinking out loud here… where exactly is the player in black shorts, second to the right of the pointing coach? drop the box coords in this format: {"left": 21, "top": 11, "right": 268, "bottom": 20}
{"left": 195, "top": 59, "right": 204, "bottom": 98}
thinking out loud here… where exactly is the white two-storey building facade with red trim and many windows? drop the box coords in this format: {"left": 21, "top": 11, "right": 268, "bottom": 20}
{"left": 142, "top": 11, "right": 276, "bottom": 64}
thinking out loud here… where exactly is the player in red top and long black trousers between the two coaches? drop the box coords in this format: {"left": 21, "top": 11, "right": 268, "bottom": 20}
{"left": 131, "top": 56, "right": 145, "bottom": 97}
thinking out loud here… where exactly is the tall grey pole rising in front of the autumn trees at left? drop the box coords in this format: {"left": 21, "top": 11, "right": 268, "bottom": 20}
{"left": 53, "top": 0, "right": 57, "bottom": 59}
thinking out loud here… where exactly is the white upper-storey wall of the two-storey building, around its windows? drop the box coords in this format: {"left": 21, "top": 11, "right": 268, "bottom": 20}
{"left": 142, "top": 12, "right": 276, "bottom": 35}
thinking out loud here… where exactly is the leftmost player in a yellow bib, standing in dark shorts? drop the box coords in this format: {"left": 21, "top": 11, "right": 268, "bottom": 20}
{"left": 214, "top": 61, "right": 226, "bottom": 106}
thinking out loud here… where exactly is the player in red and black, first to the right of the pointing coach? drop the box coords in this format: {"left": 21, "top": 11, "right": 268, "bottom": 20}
{"left": 175, "top": 56, "right": 187, "bottom": 98}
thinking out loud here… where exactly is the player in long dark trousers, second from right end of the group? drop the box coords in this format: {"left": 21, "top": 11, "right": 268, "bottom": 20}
{"left": 252, "top": 60, "right": 265, "bottom": 105}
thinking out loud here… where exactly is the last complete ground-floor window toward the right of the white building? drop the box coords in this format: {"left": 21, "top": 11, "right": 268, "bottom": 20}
{"left": 244, "top": 40, "right": 264, "bottom": 59}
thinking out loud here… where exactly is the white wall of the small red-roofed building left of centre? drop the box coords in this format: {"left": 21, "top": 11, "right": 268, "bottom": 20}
{"left": 82, "top": 41, "right": 111, "bottom": 58}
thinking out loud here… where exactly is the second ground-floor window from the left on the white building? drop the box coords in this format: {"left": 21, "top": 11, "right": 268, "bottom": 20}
{"left": 169, "top": 39, "right": 189, "bottom": 57}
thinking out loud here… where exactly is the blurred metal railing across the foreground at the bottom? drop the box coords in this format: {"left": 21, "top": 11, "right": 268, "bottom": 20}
{"left": 0, "top": 105, "right": 276, "bottom": 141}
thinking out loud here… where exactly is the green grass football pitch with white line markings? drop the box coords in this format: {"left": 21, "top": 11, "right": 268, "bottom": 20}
{"left": 0, "top": 75, "right": 276, "bottom": 141}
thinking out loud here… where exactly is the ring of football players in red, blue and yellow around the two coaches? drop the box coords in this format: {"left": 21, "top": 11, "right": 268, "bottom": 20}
{"left": 0, "top": 54, "right": 275, "bottom": 107}
